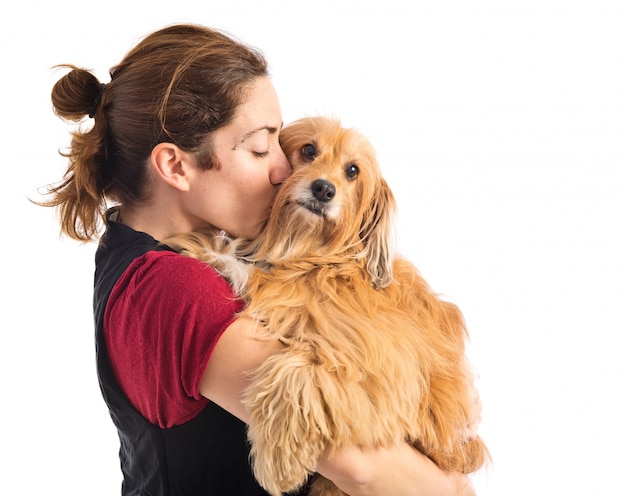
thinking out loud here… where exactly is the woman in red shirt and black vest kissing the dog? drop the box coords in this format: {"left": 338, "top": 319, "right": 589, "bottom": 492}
{"left": 42, "top": 21, "right": 473, "bottom": 496}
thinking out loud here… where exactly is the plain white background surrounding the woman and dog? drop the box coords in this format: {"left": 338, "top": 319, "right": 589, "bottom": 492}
{"left": 0, "top": 0, "right": 626, "bottom": 496}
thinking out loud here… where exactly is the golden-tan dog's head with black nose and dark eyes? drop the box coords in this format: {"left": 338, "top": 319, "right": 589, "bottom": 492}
{"left": 258, "top": 117, "right": 396, "bottom": 287}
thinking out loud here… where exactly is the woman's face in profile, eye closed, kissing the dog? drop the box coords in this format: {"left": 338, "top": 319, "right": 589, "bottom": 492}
{"left": 187, "top": 77, "right": 291, "bottom": 239}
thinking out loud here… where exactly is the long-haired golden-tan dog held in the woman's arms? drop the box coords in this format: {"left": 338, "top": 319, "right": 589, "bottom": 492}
{"left": 170, "top": 117, "right": 489, "bottom": 495}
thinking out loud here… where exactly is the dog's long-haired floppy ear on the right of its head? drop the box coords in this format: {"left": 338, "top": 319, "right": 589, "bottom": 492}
{"left": 361, "top": 179, "right": 396, "bottom": 289}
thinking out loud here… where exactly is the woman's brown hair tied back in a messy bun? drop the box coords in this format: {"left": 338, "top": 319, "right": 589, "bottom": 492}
{"left": 39, "top": 24, "right": 268, "bottom": 241}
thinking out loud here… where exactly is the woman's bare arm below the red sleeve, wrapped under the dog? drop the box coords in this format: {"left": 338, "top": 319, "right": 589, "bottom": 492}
{"left": 200, "top": 318, "right": 475, "bottom": 496}
